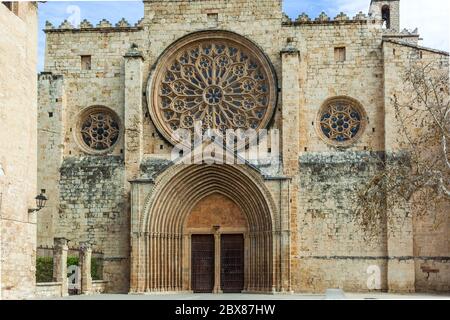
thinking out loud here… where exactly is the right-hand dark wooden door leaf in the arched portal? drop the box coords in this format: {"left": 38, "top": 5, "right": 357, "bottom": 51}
{"left": 220, "top": 234, "right": 244, "bottom": 293}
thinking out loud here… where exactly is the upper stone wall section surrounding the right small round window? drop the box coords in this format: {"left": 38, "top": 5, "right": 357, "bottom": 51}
{"left": 283, "top": 19, "right": 384, "bottom": 152}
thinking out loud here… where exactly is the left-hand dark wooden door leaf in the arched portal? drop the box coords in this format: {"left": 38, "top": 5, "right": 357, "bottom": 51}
{"left": 191, "top": 234, "right": 215, "bottom": 293}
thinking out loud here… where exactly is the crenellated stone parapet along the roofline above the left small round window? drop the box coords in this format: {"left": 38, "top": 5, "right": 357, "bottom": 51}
{"left": 44, "top": 18, "right": 143, "bottom": 32}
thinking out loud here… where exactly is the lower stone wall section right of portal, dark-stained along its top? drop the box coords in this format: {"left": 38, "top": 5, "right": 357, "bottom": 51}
{"left": 293, "top": 151, "right": 387, "bottom": 292}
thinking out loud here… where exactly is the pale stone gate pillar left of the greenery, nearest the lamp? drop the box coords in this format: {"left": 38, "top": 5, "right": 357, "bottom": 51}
{"left": 53, "top": 238, "right": 69, "bottom": 297}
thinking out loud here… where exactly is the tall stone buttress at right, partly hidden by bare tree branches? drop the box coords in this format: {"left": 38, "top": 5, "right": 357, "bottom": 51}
{"left": 383, "top": 44, "right": 415, "bottom": 292}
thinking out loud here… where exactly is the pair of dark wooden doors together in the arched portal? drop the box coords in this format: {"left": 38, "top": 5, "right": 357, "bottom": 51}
{"left": 191, "top": 234, "right": 244, "bottom": 293}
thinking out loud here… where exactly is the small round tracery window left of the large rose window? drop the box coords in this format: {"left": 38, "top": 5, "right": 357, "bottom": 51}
{"left": 78, "top": 107, "right": 120, "bottom": 152}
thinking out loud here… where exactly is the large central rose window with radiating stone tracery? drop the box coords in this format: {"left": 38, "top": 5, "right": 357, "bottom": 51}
{"left": 149, "top": 31, "right": 277, "bottom": 143}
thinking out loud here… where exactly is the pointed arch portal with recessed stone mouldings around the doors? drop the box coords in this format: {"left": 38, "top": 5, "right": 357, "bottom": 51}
{"left": 130, "top": 165, "right": 287, "bottom": 292}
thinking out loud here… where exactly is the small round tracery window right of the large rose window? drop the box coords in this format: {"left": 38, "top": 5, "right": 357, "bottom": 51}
{"left": 317, "top": 97, "right": 367, "bottom": 147}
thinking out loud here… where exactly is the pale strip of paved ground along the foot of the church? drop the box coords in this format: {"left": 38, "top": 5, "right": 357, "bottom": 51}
{"left": 38, "top": 293, "right": 450, "bottom": 300}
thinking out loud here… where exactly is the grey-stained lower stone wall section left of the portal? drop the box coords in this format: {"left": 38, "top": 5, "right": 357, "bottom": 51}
{"left": 56, "top": 156, "right": 130, "bottom": 292}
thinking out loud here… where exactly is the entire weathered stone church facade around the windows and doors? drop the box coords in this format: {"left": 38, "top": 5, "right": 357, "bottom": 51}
{"left": 38, "top": 0, "right": 450, "bottom": 293}
